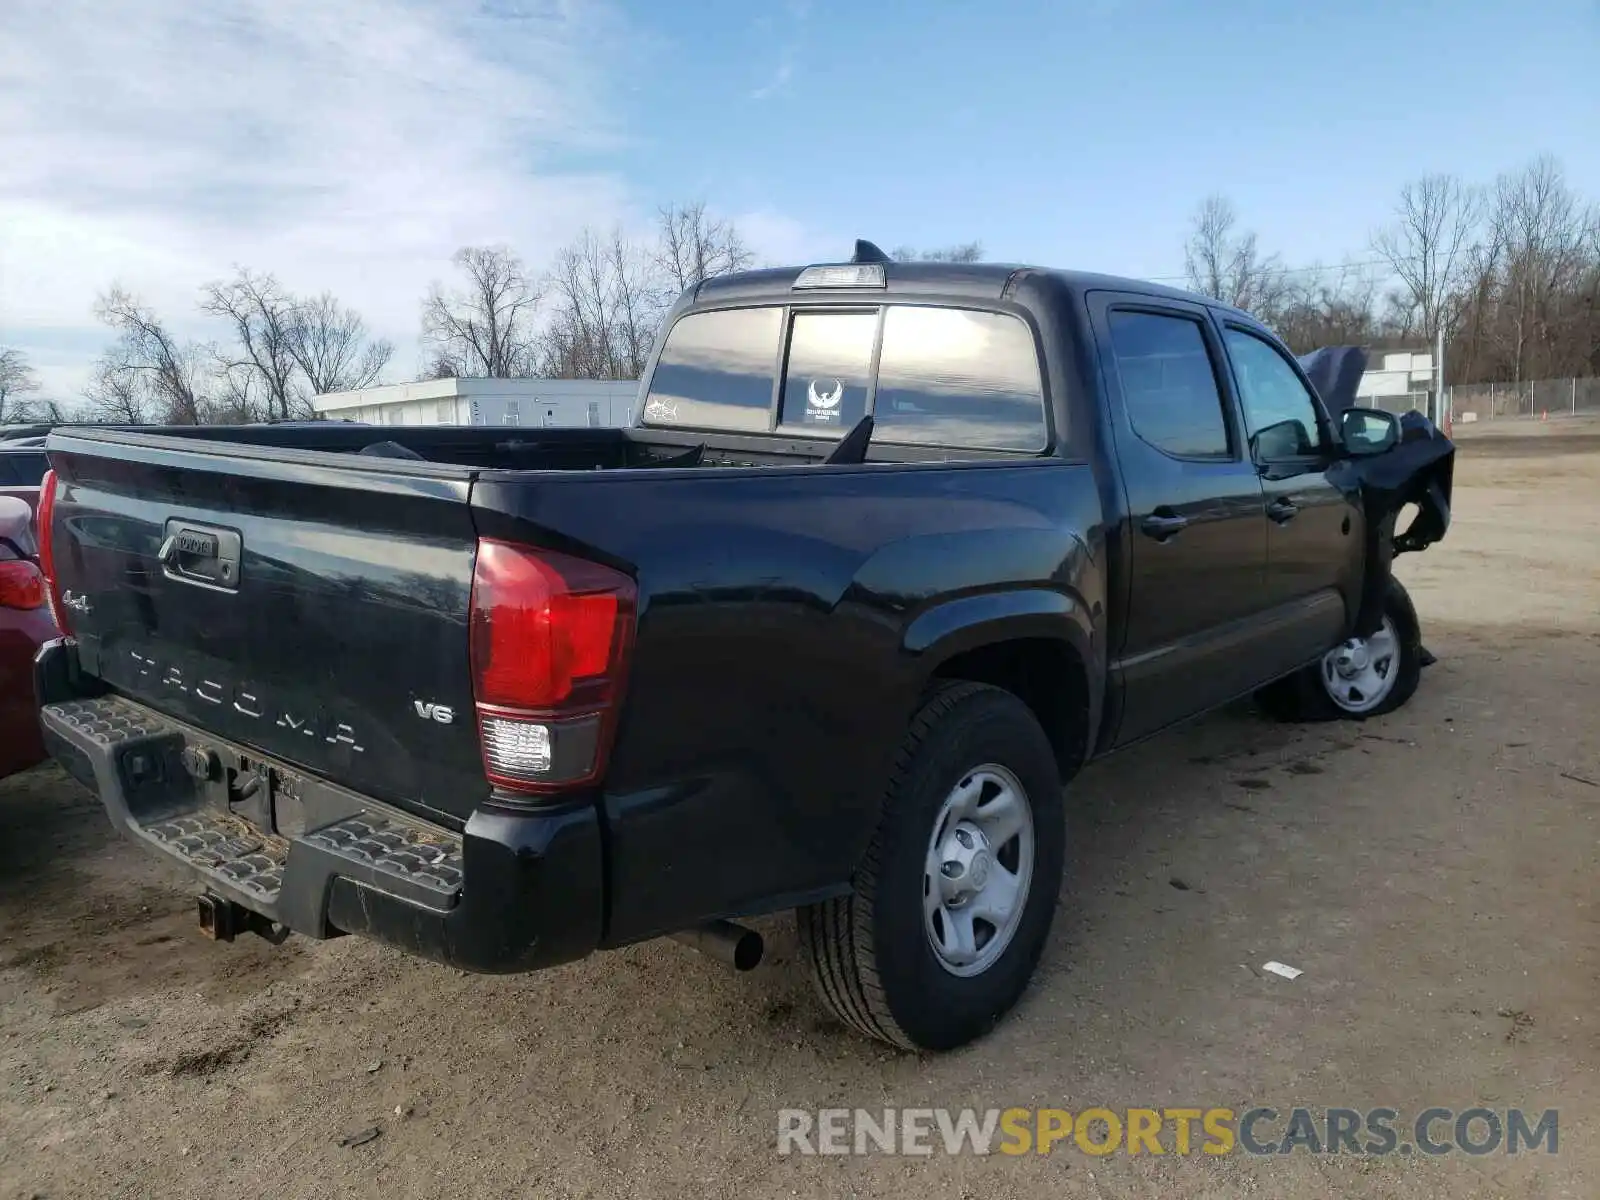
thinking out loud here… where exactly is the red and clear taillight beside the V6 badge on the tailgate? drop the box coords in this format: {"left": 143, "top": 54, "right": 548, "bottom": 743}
{"left": 469, "top": 539, "right": 637, "bottom": 792}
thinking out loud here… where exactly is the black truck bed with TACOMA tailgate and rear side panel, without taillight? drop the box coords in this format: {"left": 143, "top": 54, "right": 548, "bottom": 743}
{"left": 40, "top": 426, "right": 1106, "bottom": 944}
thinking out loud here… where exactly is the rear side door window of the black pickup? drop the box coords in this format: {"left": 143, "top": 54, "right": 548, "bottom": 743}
{"left": 1109, "top": 312, "right": 1230, "bottom": 459}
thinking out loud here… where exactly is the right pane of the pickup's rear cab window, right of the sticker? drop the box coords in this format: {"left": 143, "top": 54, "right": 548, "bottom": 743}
{"left": 872, "top": 304, "right": 1048, "bottom": 450}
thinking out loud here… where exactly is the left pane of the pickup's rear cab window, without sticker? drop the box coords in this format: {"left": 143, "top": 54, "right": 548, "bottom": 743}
{"left": 645, "top": 307, "right": 782, "bottom": 432}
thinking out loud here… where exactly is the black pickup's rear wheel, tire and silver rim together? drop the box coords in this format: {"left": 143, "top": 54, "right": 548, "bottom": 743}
{"left": 797, "top": 683, "right": 1066, "bottom": 1050}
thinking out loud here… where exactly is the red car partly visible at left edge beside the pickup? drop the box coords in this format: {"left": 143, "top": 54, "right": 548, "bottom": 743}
{"left": 0, "top": 494, "right": 56, "bottom": 776}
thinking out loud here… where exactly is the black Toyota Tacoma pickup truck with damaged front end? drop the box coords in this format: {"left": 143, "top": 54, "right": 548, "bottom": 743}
{"left": 37, "top": 243, "right": 1451, "bottom": 1048}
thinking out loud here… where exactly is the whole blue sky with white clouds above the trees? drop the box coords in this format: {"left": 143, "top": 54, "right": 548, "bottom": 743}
{"left": 0, "top": 0, "right": 1600, "bottom": 398}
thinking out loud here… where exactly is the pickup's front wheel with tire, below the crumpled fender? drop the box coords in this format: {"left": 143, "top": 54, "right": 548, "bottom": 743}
{"left": 1256, "top": 579, "right": 1426, "bottom": 722}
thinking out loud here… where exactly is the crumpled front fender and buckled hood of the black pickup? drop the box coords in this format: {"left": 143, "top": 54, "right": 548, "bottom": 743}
{"left": 1301, "top": 346, "right": 1456, "bottom": 637}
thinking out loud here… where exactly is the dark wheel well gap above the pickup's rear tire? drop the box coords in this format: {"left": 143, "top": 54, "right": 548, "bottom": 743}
{"left": 934, "top": 637, "right": 1093, "bottom": 779}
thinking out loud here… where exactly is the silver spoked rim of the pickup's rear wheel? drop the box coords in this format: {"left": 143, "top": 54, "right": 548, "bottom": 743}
{"left": 922, "top": 763, "right": 1034, "bottom": 976}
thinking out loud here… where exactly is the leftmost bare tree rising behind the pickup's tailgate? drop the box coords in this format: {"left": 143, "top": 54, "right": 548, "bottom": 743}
{"left": 88, "top": 286, "right": 214, "bottom": 426}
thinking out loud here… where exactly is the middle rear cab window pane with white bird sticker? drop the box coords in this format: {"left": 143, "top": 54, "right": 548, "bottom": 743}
{"left": 779, "top": 310, "right": 878, "bottom": 434}
